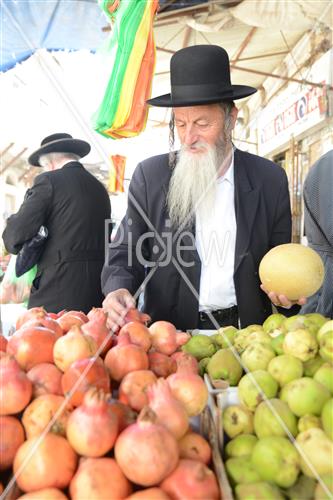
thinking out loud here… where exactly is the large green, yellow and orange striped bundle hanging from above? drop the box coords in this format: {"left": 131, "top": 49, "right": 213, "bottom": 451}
{"left": 93, "top": 0, "right": 158, "bottom": 139}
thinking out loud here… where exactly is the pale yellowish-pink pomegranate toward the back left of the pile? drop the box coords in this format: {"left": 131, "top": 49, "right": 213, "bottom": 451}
{"left": 53, "top": 326, "right": 97, "bottom": 372}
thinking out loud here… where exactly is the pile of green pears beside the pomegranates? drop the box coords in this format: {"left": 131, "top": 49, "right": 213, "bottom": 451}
{"left": 183, "top": 313, "right": 333, "bottom": 500}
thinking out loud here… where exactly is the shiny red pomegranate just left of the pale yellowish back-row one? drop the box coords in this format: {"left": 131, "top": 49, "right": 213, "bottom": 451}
{"left": 7, "top": 325, "right": 56, "bottom": 371}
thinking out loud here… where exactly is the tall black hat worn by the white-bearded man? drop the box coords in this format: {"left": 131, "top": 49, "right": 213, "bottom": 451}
{"left": 147, "top": 45, "right": 257, "bottom": 108}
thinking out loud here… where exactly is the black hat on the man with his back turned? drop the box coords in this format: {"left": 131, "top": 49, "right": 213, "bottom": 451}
{"left": 28, "top": 134, "right": 90, "bottom": 167}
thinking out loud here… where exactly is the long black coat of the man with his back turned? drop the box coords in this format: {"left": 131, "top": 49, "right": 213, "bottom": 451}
{"left": 3, "top": 161, "right": 111, "bottom": 312}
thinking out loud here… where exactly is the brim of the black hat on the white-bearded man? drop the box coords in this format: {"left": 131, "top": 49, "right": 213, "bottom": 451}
{"left": 147, "top": 85, "right": 257, "bottom": 108}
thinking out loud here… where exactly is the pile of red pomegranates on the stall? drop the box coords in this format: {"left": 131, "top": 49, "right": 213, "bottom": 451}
{"left": 0, "top": 307, "right": 223, "bottom": 500}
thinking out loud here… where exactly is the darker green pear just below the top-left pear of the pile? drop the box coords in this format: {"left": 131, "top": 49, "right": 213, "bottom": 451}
{"left": 206, "top": 349, "right": 243, "bottom": 385}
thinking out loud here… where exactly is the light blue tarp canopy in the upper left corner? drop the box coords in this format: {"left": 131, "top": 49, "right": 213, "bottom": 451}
{"left": 0, "top": 0, "right": 207, "bottom": 71}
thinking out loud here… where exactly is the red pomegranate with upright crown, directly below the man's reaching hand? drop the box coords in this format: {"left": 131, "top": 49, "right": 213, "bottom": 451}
{"left": 105, "top": 334, "right": 149, "bottom": 382}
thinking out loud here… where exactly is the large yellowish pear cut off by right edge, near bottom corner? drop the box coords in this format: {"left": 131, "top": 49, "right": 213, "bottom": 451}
{"left": 296, "top": 428, "right": 333, "bottom": 477}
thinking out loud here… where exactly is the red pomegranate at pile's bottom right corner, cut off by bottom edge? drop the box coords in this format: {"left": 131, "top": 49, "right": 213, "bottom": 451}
{"left": 160, "top": 459, "right": 221, "bottom": 500}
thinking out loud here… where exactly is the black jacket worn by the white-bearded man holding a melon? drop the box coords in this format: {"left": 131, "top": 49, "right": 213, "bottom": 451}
{"left": 102, "top": 150, "right": 291, "bottom": 329}
